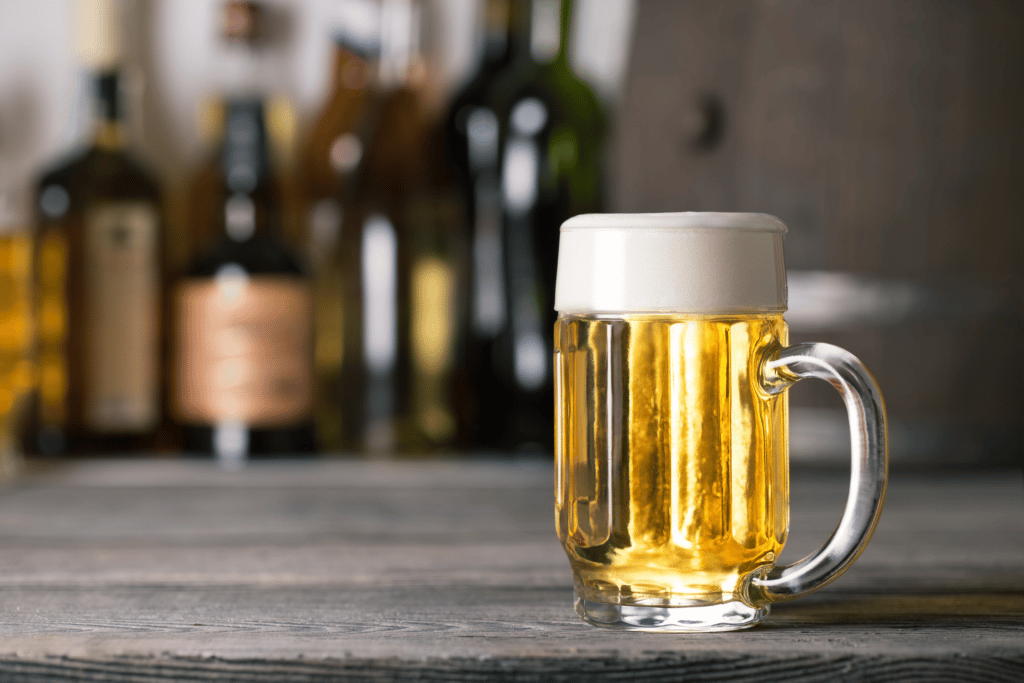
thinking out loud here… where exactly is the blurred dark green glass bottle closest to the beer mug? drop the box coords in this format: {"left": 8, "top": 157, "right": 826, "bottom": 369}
{"left": 445, "top": 0, "right": 607, "bottom": 452}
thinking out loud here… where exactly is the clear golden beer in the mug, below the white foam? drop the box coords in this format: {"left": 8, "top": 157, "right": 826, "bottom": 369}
{"left": 555, "top": 312, "right": 788, "bottom": 607}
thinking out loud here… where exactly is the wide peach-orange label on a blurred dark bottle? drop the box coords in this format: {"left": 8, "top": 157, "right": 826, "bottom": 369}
{"left": 175, "top": 274, "right": 313, "bottom": 427}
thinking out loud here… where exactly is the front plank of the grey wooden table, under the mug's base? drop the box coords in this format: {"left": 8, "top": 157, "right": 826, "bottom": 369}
{"left": 0, "top": 587, "right": 1024, "bottom": 681}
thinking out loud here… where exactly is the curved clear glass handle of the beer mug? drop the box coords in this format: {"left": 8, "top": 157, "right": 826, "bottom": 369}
{"left": 750, "top": 344, "right": 889, "bottom": 604}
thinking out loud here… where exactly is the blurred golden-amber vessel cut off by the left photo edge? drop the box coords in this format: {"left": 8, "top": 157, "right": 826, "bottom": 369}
{"left": 0, "top": 181, "right": 34, "bottom": 481}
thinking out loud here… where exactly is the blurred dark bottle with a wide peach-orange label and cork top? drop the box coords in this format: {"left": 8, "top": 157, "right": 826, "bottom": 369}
{"left": 173, "top": 2, "right": 314, "bottom": 467}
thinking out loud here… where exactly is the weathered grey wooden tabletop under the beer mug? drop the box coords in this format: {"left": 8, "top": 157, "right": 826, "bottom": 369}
{"left": 0, "top": 460, "right": 1024, "bottom": 682}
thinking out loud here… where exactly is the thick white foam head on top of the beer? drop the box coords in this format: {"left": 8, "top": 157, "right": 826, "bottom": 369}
{"left": 555, "top": 212, "right": 786, "bottom": 314}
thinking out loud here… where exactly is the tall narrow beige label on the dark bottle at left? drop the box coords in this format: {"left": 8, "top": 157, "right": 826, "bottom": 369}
{"left": 84, "top": 202, "right": 160, "bottom": 433}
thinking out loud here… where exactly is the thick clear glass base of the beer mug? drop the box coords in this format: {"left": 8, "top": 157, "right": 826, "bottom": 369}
{"left": 575, "top": 594, "right": 768, "bottom": 633}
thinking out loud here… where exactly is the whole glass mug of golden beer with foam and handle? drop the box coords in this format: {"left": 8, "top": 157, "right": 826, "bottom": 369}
{"left": 555, "top": 213, "right": 888, "bottom": 631}
